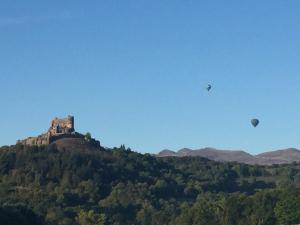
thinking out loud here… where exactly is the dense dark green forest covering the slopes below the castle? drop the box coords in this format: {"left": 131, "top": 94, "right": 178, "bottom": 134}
{"left": 0, "top": 145, "right": 300, "bottom": 225}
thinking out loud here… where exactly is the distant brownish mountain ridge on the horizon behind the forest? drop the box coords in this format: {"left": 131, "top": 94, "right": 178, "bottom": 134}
{"left": 157, "top": 147, "right": 300, "bottom": 165}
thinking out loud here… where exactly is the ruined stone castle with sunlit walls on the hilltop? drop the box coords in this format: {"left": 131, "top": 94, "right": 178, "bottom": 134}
{"left": 17, "top": 116, "right": 84, "bottom": 146}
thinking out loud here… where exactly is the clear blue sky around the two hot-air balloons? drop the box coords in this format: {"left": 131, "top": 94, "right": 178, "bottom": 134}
{"left": 0, "top": 0, "right": 300, "bottom": 153}
